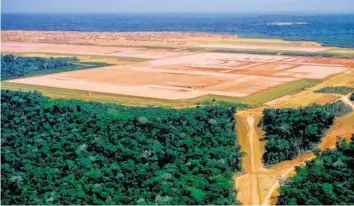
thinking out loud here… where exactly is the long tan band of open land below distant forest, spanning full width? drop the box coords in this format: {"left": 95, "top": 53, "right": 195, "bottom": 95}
{"left": 1, "top": 31, "right": 354, "bottom": 57}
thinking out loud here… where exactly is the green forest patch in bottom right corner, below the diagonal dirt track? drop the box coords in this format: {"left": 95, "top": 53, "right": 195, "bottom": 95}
{"left": 277, "top": 134, "right": 354, "bottom": 205}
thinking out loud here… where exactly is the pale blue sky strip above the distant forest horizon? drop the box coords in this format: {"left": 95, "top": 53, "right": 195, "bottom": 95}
{"left": 1, "top": 0, "right": 354, "bottom": 14}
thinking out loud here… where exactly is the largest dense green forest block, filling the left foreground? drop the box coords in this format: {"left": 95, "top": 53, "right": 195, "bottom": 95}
{"left": 1, "top": 90, "right": 242, "bottom": 205}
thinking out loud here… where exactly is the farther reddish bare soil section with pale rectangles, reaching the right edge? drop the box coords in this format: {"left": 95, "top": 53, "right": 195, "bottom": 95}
{"left": 143, "top": 52, "right": 348, "bottom": 79}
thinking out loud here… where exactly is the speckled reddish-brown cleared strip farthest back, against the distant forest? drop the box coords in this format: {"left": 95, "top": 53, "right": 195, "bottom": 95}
{"left": 1, "top": 31, "right": 238, "bottom": 48}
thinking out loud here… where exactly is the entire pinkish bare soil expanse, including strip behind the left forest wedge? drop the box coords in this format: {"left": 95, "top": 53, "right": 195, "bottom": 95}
{"left": 2, "top": 42, "right": 354, "bottom": 100}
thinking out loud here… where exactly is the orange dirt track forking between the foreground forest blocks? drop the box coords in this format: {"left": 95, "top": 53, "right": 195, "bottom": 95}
{"left": 235, "top": 96, "right": 354, "bottom": 205}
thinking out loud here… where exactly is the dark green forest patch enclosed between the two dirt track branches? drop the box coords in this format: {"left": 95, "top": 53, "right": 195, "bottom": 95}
{"left": 262, "top": 102, "right": 351, "bottom": 165}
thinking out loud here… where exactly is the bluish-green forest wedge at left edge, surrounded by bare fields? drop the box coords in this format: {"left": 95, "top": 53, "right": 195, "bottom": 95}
{"left": 1, "top": 55, "right": 107, "bottom": 80}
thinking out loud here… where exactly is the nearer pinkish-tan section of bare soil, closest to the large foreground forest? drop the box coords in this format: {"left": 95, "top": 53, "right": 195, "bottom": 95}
{"left": 9, "top": 66, "right": 296, "bottom": 100}
